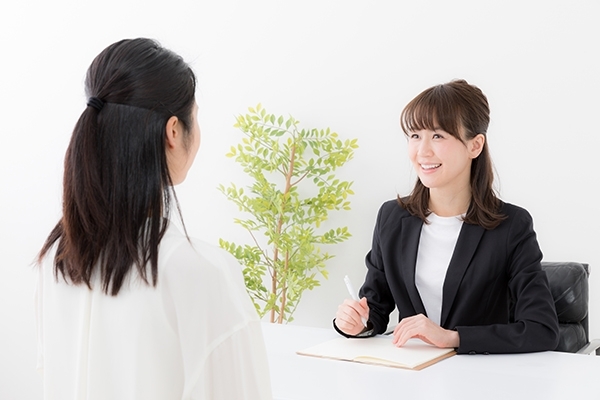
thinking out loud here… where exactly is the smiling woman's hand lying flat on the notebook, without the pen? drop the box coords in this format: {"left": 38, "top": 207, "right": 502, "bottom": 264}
{"left": 392, "top": 314, "right": 460, "bottom": 347}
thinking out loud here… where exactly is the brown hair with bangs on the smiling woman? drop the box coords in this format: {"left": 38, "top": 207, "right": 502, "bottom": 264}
{"left": 398, "top": 80, "right": 506, "bottom": 229}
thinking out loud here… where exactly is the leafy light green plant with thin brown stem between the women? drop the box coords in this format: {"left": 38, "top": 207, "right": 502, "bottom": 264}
{"left": 219, "top": 104, "right": 358, "bottom": 323}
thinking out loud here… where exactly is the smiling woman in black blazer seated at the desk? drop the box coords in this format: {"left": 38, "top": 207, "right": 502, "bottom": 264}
{"left": 334, "top": 80, "right": 558, "bottom": 354}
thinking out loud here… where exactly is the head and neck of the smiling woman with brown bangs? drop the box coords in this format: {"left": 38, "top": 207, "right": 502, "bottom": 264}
{"left": 400, "top": 80, "right": 503, "bottom": 229}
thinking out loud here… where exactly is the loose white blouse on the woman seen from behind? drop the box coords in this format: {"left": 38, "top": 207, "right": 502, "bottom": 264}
{"left": 36, "top": 223, "right": 272, "bottom": 400}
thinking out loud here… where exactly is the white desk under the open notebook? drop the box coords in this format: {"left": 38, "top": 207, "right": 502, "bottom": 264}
{"left": 263, "top": 323, "right": 600, "bottom": 400}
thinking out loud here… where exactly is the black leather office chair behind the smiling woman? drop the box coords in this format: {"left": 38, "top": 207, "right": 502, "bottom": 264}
{"left": 542, "top": 261, "right": 600, "bottom": 355}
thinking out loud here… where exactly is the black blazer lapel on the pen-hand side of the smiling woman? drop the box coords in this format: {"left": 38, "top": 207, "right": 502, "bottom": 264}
{"left": 400, "top": 217, "right": 427, "bottom": 315}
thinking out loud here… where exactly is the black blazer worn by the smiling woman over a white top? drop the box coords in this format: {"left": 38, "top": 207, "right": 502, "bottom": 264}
{"left": 342, "top": 200, "right": 558, "bottom": 354}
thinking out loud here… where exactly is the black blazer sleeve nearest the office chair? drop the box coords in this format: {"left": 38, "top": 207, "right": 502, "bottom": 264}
{"left": 456, "top": 208, "right": 558, "bottom": 354}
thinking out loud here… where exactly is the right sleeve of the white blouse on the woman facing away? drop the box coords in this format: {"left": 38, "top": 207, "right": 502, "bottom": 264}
{"left": 159, "top": 238, "right": 271, "bottom": 399}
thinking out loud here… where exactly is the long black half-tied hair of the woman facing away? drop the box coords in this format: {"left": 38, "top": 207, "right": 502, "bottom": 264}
{"left": 38, "top": 38, "right": 196, "bottom": 295}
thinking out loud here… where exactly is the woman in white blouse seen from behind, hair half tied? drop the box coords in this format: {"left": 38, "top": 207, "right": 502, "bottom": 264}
{"left": 36, "top": 38, "right": 271, "bottom": 400}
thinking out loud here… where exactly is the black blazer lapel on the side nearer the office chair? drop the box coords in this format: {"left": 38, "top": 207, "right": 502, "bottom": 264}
{"left": 440, "top": 224, "right": 485, "bottom": 326}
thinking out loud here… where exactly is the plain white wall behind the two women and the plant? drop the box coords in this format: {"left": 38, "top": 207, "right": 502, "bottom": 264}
{"left": 0, "top": 0, "right": 600, "bottom": 399}
